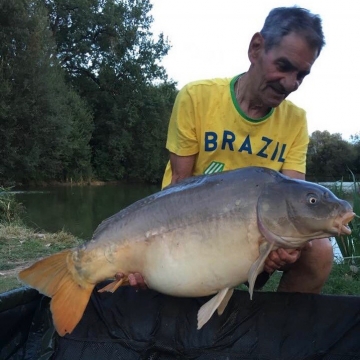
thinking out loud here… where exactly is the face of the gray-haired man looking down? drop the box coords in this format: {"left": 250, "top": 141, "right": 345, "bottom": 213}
{"left": 249, "top": 33, "right": 318, "bottom": 107}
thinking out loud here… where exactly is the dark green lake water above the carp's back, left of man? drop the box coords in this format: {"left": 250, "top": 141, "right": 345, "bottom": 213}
{"left": 15, "top": 184, "right": 160, "bottom": 239}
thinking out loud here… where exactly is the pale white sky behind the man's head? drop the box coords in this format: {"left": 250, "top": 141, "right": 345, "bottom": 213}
{"left": 151, "top": 0, "right": 360, "bottom": 140}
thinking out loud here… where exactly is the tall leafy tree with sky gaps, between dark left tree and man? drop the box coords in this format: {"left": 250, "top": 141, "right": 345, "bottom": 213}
{"left": 46, "top": 0, "right": 176, "bottom": 181}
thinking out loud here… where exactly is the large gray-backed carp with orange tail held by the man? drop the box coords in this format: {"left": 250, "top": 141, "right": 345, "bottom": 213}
{"left": 19, "top": 167, "right": 355, "bottom": 335}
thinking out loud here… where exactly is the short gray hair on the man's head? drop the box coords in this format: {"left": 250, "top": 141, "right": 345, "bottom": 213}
{"left": 260, "top": 6, "right": 325, "bottom": 56}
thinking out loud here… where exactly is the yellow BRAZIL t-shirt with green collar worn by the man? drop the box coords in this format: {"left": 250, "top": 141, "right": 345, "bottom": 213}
{"left": 162, "top": 76, "right": 309, "bottom": 187}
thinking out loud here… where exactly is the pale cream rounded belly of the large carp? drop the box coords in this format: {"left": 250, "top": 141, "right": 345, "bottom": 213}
{"left": 142, "top": 218, "right": 261, "bottom": 297}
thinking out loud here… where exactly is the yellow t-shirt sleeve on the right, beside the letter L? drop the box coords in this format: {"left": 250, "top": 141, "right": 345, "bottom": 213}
{"left": 282, "top": 110, "right": 309, "bottom": 174}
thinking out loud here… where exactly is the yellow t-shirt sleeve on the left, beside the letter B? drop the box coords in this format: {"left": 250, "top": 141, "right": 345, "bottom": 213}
{"left": 166, "top": 85, "right": 199, "bottom": 156}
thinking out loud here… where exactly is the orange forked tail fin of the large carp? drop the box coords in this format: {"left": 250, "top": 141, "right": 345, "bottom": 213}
{"left": 19, "top": 250, "right": 95, "bottom": 336}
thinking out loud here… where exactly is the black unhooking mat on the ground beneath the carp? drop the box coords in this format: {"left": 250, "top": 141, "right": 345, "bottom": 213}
{"left": 0, "top": 284, "right": 360, "bottom": 360}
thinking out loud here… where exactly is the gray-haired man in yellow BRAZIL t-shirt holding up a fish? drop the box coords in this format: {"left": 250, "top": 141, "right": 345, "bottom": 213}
{"left": 129, "top": 7, "right": 333, "bottom": 293}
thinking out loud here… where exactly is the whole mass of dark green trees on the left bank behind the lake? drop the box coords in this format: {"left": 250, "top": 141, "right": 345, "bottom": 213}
{"left": 0, "top": 0, "right": 176, "bottom": 184}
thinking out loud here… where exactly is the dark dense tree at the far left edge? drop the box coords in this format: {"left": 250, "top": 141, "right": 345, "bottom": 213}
{"left": 0, "top": 0, "right": 92, "bottom": 183}
